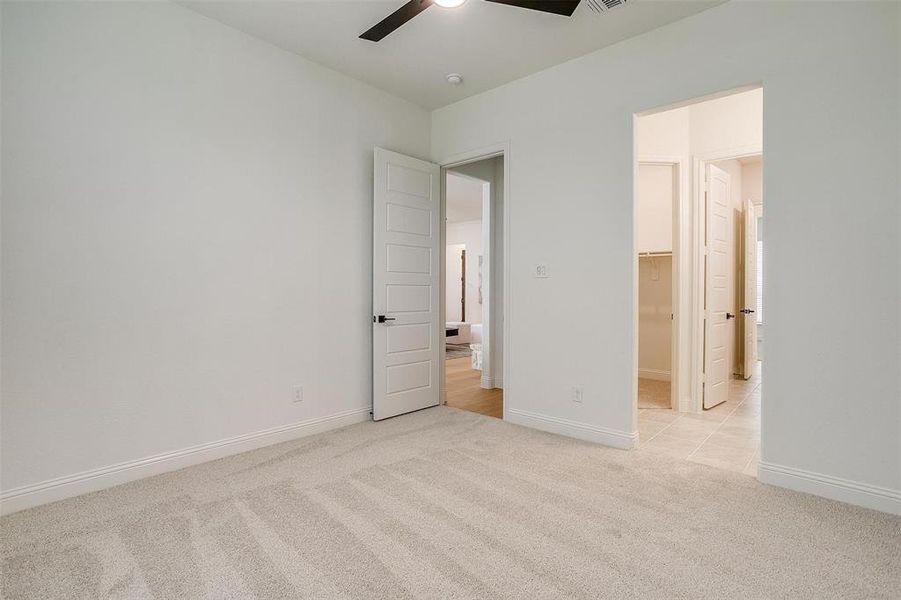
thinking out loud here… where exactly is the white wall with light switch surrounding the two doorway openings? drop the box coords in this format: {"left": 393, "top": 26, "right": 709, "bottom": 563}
{"left": 432, "top": 2, "right": 901, "bottom": 507}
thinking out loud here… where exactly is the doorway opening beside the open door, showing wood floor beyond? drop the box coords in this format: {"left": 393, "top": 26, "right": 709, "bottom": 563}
{"left": 441, "top": 156, "right": 504, "bottom": 418}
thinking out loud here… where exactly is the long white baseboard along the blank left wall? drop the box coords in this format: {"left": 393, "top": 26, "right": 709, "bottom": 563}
{"left": 0, "top": 408, "right": 369, "bottom": 515}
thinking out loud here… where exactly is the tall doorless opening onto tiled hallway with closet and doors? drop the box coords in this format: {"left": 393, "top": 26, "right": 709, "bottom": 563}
{"left": 634, "top": 88, "right": 763, "bottom": 475}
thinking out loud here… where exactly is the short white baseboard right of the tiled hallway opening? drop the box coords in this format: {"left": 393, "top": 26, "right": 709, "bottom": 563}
{"left": 757, "top": 462, "right": 901, "bottom": 515}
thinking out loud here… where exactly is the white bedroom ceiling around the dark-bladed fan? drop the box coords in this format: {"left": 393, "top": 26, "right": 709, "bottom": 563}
{"left": 178, "top": 0, "right": 725, "bottom": 109}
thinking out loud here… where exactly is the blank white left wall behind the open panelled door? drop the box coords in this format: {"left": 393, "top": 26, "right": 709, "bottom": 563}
{"left": 2, "top": 2, "right": 430, "bottom": 506}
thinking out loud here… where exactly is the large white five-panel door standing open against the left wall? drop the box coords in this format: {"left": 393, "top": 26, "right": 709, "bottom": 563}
{"left": 372, "top": 148, "right": 441, "bottom": 421}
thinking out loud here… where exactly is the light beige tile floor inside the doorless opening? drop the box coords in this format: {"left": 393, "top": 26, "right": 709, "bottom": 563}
{"left": 638, "top": 363, "right": 761, "bottom": 477}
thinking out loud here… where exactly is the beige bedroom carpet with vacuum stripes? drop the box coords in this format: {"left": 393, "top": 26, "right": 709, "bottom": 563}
{"left": 0, "top": 407, "right": 901, "bottom": 600}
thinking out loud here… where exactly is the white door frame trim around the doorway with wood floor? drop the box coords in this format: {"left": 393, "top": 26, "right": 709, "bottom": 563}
{"left": 435, "top": 142, "right": 513, "bottom": 420}
